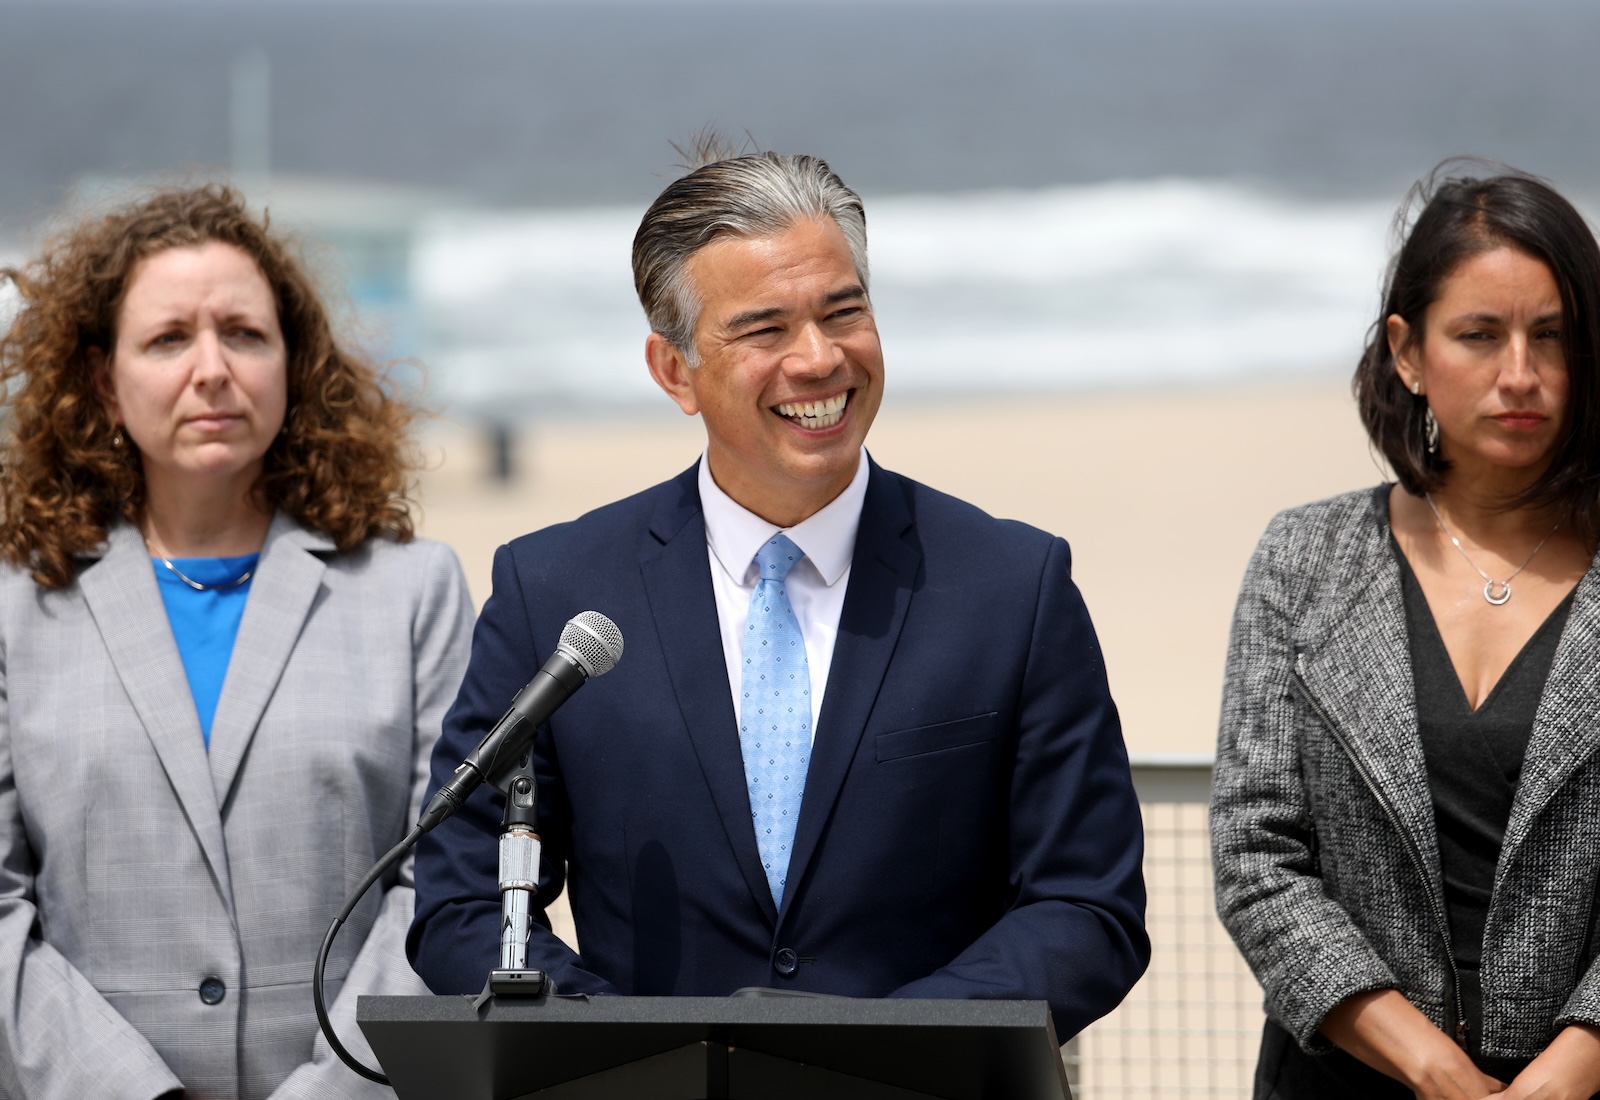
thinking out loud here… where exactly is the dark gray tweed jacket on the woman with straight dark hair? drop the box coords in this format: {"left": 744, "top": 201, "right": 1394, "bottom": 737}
{"left": 1211, "top": 486, "right": 1600, "bottom": 1058}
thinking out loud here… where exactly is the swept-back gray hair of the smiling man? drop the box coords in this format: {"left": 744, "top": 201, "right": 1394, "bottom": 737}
{"left": 634, "top": 152, "right": 867, "bottom": 366}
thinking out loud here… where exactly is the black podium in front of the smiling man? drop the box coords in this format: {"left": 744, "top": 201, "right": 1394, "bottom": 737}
{"left": 357, "top": 996, "right": 1070, "bottom": 1100}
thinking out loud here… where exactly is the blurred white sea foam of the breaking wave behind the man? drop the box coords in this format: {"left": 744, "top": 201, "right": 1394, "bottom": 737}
{"left": 413, "top": 181, "right": 1390, "bottom": 413}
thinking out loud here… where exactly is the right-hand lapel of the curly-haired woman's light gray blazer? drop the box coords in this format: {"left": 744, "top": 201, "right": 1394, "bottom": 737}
{"left": 211, "top": 512, "right": 329, "bottom": 806}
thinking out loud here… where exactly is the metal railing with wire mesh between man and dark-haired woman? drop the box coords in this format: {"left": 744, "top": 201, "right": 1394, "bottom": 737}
{"left": 1062, "top": 755, "right": 1262, "bottom": 1100}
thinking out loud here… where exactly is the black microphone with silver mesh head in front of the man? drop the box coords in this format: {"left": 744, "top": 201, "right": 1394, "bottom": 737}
{"left": 418, "top": 611, "right": 622, "bottom": 833}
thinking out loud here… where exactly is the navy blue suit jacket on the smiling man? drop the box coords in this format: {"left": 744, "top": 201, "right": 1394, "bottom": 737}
{"left": 408, "top": 465, "right": 1149, "bottom": 1039}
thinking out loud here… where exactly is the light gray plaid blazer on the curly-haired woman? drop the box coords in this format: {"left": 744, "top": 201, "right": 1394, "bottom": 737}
{"left": 0, "top": 515, "right": 472, "bottom": 1100}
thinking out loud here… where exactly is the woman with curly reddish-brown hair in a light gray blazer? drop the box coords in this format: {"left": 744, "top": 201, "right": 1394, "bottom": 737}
{"left": 0, "top": 185, "right": 472, "bottom": 1100}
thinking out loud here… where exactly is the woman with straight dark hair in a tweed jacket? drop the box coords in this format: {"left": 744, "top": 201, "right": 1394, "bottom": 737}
{"left": 1211, "top": 166, "right": 1600, "bottom": 1098}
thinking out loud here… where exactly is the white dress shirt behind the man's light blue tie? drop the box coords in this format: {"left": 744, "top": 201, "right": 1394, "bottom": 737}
{"left": 699, "top": 448, "right": 867, "bottom": 740}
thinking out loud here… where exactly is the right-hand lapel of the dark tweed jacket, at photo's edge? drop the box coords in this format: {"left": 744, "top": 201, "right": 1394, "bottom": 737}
{"left": 1496, "top": 555, "right": 1600, "bottom": 856}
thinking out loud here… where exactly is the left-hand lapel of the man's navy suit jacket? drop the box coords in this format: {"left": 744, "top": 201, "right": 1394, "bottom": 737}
{"left": 640, "top": 467, "right": 777, "bottom": 921}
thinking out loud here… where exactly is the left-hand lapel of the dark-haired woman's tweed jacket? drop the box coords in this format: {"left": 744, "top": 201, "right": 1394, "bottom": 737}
{"left": 1296, "top": 489, "right": 1443, "bottom": 889}
